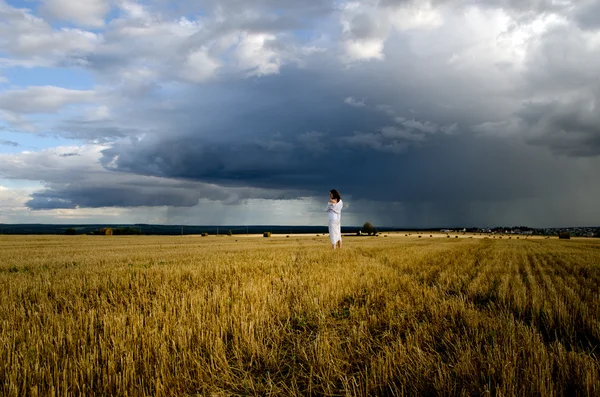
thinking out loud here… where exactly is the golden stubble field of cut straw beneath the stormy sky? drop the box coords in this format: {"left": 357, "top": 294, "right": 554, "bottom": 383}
{"left": 0, "top": 234, "right": 600, "bottom": 396}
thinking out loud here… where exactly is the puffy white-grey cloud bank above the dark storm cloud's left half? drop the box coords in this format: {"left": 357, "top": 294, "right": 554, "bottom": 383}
{"left": 89, "top": 2, "right": 296, "bottom": 83}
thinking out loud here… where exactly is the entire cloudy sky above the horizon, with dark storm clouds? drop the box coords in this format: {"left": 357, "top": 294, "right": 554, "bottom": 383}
{"left": 0, "top": 0, "right": 600, "bottom": 227}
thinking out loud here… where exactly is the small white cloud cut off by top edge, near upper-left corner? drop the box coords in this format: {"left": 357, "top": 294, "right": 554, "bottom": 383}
{"left": 42, "top": 0, "right": 110, "bottom": 27}
